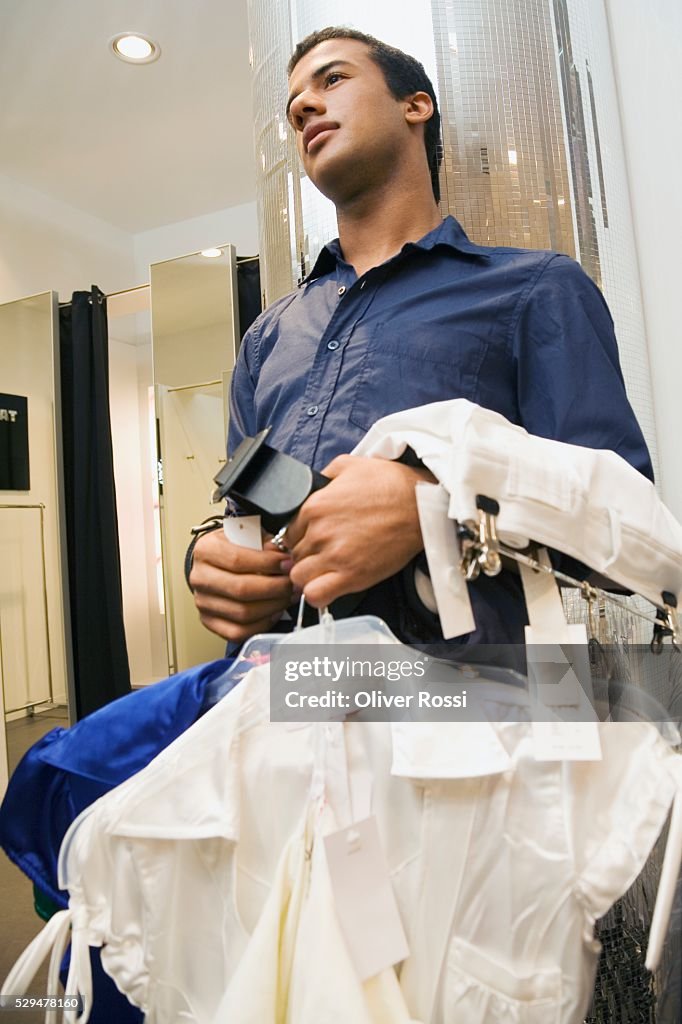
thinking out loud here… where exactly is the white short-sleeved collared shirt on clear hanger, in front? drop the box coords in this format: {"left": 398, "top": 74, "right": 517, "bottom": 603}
{"left": 3, "top": 643, "right": 680, "bottom": 1024}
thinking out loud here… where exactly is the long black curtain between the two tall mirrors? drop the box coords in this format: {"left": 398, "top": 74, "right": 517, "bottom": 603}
{"left": 59, "top": 286, "right": 130, "bottom": 718}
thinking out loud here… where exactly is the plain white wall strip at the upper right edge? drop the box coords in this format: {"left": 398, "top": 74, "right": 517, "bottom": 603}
{"left": 606, "top": 0, "right": 682, "bottom": 519}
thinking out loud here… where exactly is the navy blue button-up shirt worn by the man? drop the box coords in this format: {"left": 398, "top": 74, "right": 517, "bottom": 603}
{"left": 228, "top": 217, "right": 652, "bottom": 643}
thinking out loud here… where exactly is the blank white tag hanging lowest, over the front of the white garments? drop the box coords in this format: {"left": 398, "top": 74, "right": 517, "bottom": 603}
{"left": 325, "top": 816, "right": 410, "bottom": 981}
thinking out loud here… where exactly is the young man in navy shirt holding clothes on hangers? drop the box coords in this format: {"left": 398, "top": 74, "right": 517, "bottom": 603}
{"left": 189, "top": 29, "right": 651, "bottom": 643}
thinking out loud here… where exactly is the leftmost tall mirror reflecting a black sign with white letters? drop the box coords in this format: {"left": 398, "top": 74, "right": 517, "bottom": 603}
{"left": 0, "top": 292, "right": 71, "bottom": 795}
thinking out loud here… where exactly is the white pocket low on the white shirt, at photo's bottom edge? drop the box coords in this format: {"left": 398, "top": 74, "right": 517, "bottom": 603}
{"left": 442, "top": 938, "right": 561, "bottom": 1024}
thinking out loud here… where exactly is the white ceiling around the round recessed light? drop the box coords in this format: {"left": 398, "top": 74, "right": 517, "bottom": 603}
{"left": 0, "top": 0, "right": 255, "bottom": 232}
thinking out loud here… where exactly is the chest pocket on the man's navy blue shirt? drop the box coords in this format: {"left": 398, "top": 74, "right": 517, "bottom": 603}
{"left": 349, "top": 321, "right": 487, "bottom": 430}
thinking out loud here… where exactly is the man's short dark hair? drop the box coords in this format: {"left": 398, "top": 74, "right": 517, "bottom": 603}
{"left": 287, "top": 26, "right": 442, "bottom": 203}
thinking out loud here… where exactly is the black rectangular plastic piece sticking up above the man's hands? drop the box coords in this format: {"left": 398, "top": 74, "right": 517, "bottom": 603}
{"left": 213, "top": 427, "right": 330, "bottom": 534}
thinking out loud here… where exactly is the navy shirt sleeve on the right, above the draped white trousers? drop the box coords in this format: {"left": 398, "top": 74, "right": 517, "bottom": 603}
{"left": 512, "top": 255, "right": 653, "bottom": 480}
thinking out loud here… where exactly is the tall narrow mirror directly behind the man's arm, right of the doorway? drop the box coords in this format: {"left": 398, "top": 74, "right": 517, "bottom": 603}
{"left": 150, "top": 245, "right": 240, "bottom": 672}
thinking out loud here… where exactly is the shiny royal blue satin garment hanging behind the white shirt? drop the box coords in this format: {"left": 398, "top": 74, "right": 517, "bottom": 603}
{"left": 0, "top": 658, "right": 233, "bottom": 1024}
